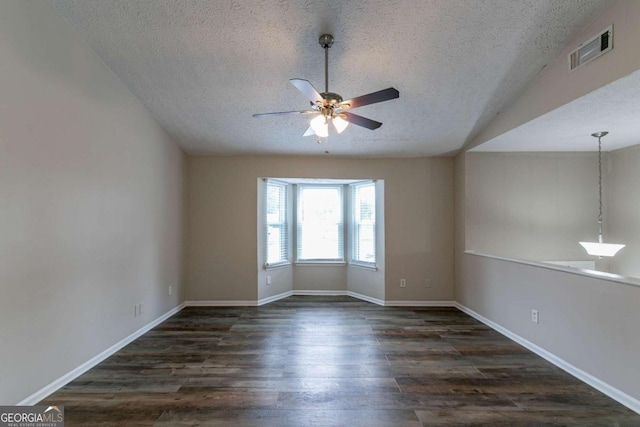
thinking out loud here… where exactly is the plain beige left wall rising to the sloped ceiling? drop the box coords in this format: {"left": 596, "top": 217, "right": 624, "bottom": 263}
{"left": 0, "top": 1, "right": 185, "bottom": 404}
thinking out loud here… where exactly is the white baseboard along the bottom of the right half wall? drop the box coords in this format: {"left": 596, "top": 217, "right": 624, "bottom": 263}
{"left": 455, "top": 302, "right": 640, "bottom": 414}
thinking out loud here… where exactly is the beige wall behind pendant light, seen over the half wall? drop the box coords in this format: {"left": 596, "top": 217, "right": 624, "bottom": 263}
{"left": 465, "top": 153, "right": 598, "bottom": 261}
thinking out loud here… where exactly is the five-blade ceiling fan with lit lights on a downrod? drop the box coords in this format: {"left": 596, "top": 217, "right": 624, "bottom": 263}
{"left": 253, "top": 34, "right": 400, "bottom": 138}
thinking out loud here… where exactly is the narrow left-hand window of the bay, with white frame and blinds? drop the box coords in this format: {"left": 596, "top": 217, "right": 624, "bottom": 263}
{"left": 264, "top": 179, "right": 291, "bottom": 269}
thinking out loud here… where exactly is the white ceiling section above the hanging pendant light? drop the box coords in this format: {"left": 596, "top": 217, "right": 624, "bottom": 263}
{"left": 471, "top": 71, "right": 640, "bottom": 152}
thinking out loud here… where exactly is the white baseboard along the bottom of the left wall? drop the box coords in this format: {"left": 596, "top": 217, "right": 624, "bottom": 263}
{"left": 16, "top": 303, "right": 185, "bottom": 406}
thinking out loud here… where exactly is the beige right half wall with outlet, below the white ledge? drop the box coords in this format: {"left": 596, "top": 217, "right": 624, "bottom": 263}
{"left": 456, "top": 255, "right": 640, "bottom": 407}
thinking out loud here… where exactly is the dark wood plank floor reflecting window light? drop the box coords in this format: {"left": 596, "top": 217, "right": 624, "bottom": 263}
{"left": 41, "top": 297, "right": 640, "bottom": 426}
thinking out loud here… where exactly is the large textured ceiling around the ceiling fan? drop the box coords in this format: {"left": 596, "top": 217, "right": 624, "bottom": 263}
{"left": 50, "top": 0, "right": 611, "bottom": 157}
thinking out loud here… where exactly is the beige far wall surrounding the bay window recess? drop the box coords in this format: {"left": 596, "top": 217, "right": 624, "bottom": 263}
{"left": 186, "top": 157, "right": 453, "bottom": 301}
